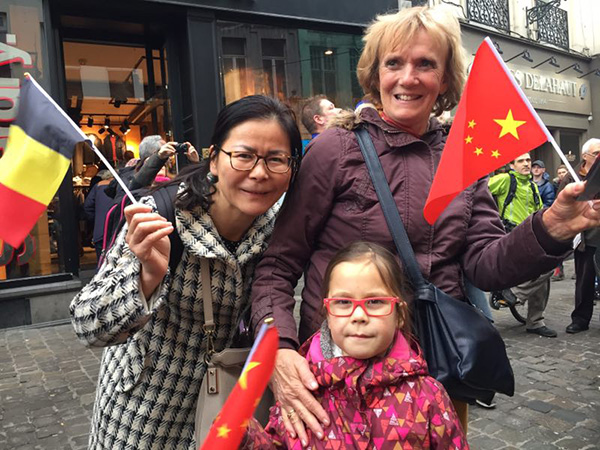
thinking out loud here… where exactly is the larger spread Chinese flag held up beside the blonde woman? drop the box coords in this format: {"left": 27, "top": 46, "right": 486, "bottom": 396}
{"left": 423, "top": 38, "right": 551, "bottom": 224}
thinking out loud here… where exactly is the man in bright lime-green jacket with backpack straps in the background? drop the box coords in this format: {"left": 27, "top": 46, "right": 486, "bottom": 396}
{"left": 488, "top": 153, "right": 557, "bottom": 337}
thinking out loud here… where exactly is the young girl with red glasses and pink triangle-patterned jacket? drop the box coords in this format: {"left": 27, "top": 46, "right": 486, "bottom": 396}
{"left": 243, "top": 242, "right": 469, "bottom": 450}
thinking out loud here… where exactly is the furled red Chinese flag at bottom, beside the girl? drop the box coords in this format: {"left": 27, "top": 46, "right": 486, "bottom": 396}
{"left": 200, "top": 319, "right": 279, "bottom": 450}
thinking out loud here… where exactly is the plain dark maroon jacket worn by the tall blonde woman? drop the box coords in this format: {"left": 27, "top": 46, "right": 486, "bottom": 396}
{"left": 252, "top": 108, "right": 570, "bottom": 349}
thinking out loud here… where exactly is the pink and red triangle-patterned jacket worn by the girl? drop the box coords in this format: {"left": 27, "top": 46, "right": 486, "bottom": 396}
{"left": 241, "top": 331, "right": 469, "bottom": 450}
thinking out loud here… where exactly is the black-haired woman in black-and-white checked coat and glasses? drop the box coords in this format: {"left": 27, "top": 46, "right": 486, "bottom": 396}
{"left": 70, "top": 95, "right": 302, "bottom": 450}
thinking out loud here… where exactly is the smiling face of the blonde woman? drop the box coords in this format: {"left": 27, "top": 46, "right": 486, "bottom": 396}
{"left": 379, "top": 30, "right": 447, "bottom": 136}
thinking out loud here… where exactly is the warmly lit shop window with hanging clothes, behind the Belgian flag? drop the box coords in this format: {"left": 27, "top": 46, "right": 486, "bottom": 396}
{"left": 63, "top": 41, "right": 172, "bottom": 269}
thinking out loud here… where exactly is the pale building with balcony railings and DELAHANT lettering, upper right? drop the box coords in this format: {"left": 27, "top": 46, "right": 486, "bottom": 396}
{"left": 429, "top": 0, "right": 600, "bottom": 172}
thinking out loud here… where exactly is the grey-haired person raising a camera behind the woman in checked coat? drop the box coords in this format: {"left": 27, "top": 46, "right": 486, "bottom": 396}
{"left": 129, "top": 135, "right": 200, "bottom": 190}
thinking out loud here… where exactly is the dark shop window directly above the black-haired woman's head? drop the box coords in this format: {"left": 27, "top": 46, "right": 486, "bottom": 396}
{"left": 219, "top": 22, "right": 362, "bottom": 134}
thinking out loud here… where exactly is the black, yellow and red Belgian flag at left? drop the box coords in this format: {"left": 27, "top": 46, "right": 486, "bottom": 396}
{"left": 0, "top": 75, "right": 86, "bottom": 248}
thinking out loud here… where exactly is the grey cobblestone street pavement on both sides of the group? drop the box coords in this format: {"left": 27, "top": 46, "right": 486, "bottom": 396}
{"left": 0, "top": 262, "right": 600, "bottom": 450}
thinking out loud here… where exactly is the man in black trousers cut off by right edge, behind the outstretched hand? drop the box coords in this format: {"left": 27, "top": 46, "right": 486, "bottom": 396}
{"left": 559, "top": 139, "right": 600, "bottom": 334}
